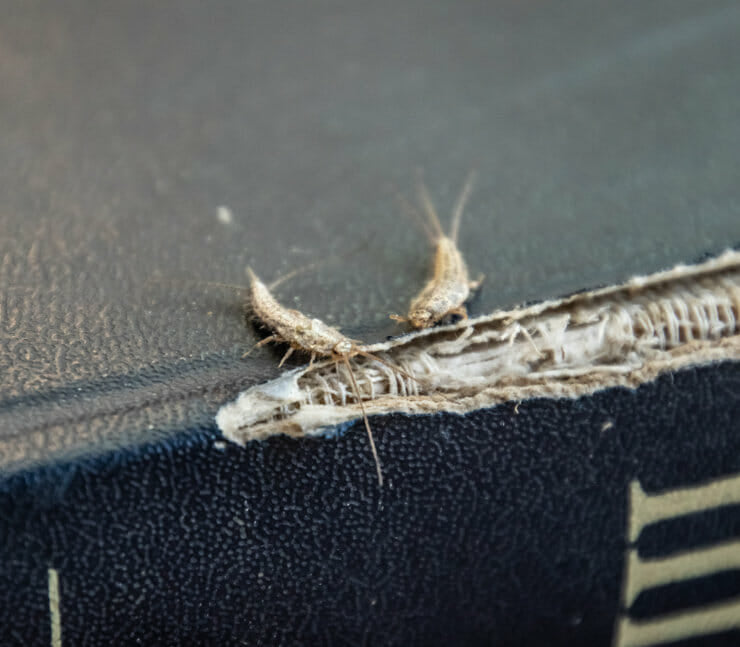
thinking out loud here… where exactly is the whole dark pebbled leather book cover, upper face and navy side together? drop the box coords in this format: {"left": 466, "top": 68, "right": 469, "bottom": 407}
{"left": 0, "top": 0, "right": 740, "bottom": 645}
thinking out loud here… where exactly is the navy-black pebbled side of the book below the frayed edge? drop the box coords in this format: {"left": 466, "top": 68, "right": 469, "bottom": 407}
{"left": 0, "top": 363, "right": 740, "bottom": 646}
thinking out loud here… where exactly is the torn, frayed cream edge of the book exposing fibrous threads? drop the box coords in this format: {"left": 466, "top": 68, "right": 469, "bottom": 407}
{"left": 216, "top": 250, "right": 740, "bottom": 444}
